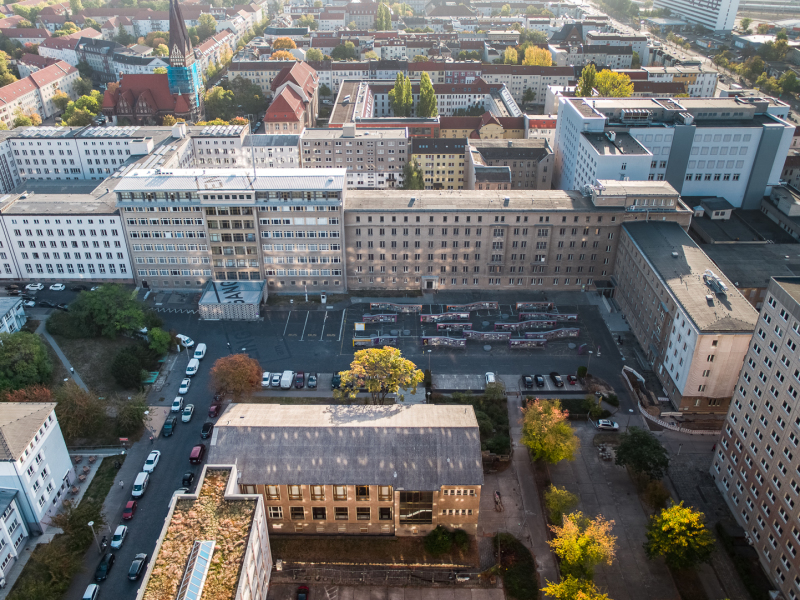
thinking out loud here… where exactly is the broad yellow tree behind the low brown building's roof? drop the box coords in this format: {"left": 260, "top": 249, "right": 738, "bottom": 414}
{"left": 333, "top": 346, "right": 423, "bottom": 404}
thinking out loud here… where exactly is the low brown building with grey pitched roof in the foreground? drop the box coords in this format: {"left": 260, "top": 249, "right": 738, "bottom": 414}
{"left": 209, "top": 404, "right": 483, "bottom": 536}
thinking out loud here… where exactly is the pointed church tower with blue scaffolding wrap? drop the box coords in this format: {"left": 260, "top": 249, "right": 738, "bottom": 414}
{"left": 167, "top": 0, "right": 205, "bottom": 122}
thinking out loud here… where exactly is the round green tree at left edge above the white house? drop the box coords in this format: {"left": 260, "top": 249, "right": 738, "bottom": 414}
{"left": 0, "top": 331, "right": 53, "bottom": 390}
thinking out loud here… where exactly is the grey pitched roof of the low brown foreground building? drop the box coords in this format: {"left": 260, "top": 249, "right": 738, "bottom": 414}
{"left": 209, "top": 404, "right": 483, "bottom": 491}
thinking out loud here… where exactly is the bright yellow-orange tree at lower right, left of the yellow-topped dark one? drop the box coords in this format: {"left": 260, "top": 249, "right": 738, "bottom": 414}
{"left": 547, "top": 511, "right": 617, "bottom": 579}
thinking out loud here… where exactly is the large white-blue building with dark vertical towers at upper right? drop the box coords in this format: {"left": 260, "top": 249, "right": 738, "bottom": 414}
{"left": 553, "top": 98, "right": 794, "bottom": 209}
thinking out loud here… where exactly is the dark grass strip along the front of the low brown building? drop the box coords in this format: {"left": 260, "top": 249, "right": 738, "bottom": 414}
{"left": 269, "top": 535, "right": 479, "bottom": 567}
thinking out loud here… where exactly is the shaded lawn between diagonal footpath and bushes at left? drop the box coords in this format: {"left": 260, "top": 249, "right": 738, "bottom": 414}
{"left": 53, "top": 335, "right": 138, "bottom": 397}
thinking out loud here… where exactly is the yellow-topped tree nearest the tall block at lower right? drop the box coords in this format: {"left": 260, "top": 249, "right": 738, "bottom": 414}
{"left": 644, "top": 501, "right": 714, "bottom": 569}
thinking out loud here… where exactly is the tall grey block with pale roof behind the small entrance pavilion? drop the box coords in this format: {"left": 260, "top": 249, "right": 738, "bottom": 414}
{"left": 114, "top": 168, "right": 346, "bottom": 292}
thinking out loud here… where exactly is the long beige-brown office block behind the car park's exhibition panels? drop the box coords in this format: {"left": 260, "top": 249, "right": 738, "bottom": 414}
{"left": 344, "top": 181, "right": 692, "bottom": 290}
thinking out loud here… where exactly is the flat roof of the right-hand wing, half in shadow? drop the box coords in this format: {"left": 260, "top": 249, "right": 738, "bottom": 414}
{"left": 623, "top": 221, "right": 758, "bottom": 333}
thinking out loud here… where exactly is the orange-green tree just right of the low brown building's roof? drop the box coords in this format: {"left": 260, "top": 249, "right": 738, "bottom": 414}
{"left": 522, "top": 398, "right": 580, "bottom": 464}
